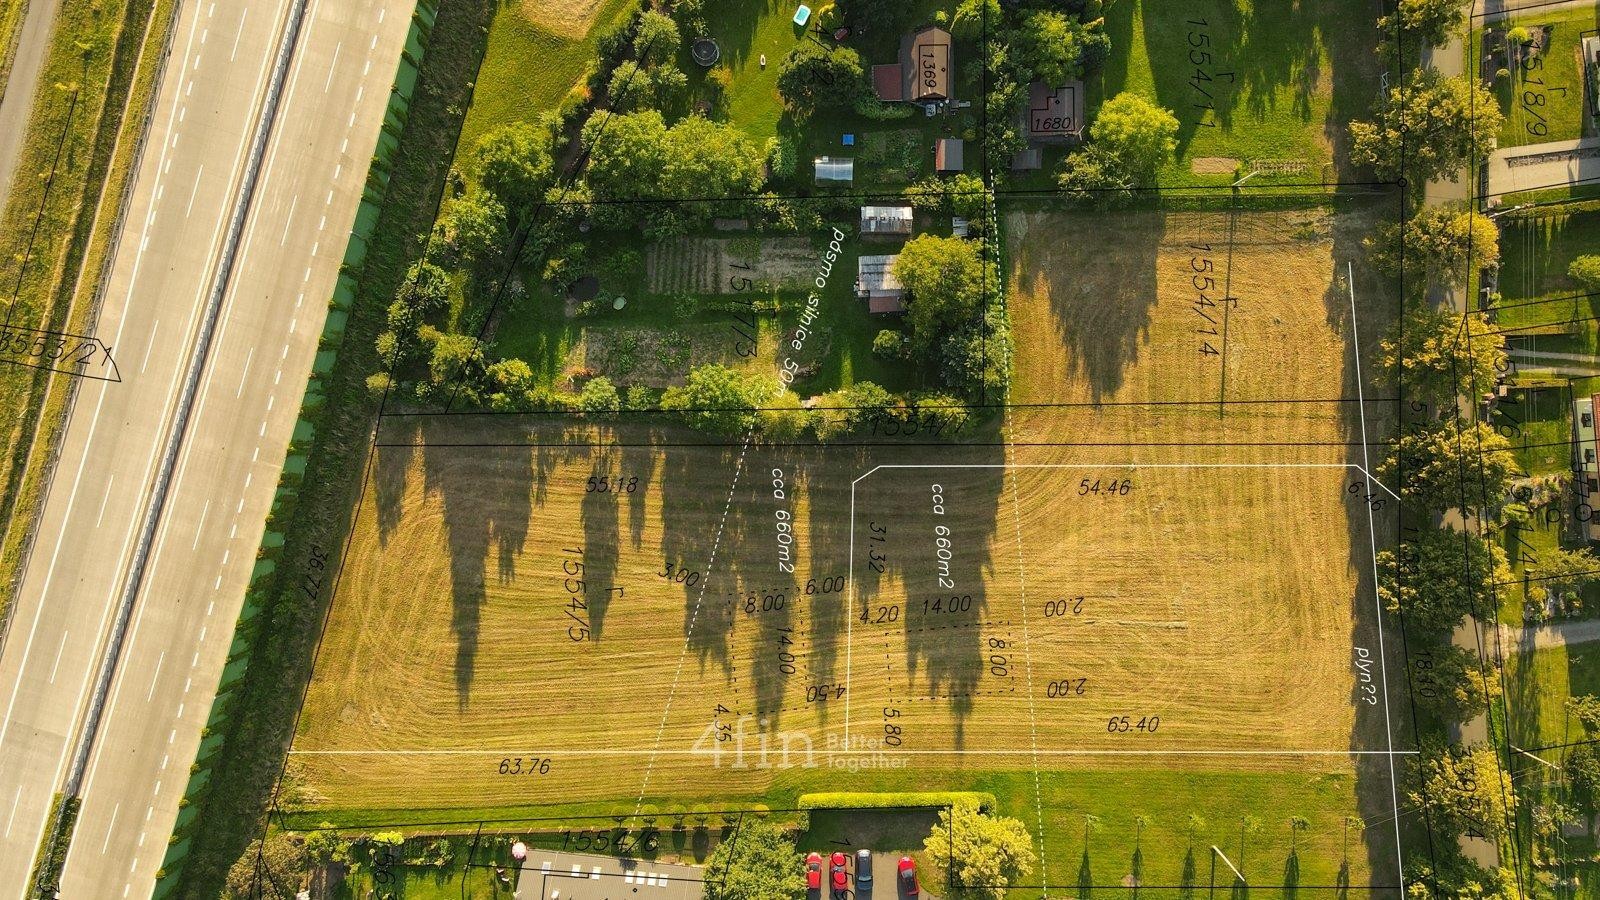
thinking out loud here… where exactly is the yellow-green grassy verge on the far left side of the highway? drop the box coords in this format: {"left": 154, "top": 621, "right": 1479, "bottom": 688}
{"left": 0, "top": 0, "right": 178, "bottom": 623}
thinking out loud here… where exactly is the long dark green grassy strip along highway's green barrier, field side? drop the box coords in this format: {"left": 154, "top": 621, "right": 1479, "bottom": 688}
{"left": 165, "top": 0, "right": 494, "bottom": 897}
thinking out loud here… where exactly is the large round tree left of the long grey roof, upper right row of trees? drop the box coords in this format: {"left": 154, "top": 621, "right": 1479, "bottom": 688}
{"left": 1350, "top": 67, "right": 1504, "bottom": 186}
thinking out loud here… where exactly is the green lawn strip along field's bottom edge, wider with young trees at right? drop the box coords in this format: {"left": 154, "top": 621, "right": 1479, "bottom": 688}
{"left": 284, "top": 764, "right": 1394, "bottom": 900}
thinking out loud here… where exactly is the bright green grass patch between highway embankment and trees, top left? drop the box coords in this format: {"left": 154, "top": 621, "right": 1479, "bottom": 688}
{"left": 456, "top": 0, "right": 632, "bottom": 159}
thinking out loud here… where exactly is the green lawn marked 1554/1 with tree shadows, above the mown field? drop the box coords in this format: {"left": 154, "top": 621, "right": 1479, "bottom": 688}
{"left": 1090, "top": 0, "right": 1376, "bottom": 186}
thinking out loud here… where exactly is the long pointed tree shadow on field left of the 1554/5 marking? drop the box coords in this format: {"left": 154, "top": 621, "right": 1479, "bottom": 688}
{"left": 422, "top": 420, "right": 534, "bottom": 709}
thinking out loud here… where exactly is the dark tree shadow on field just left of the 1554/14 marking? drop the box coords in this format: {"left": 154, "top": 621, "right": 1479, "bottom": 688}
{"left": 1013, "top": 211, "right": 1165, "bottom": 404}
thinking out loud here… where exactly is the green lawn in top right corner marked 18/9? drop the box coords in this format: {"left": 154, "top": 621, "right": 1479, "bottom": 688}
{"left": 1469, "top": 10, "right": 1595, "bottom": 147}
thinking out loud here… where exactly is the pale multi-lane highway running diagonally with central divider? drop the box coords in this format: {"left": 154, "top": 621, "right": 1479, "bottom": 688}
{"left": 0, "top": 0, "right": 413, "bottom": 898}
